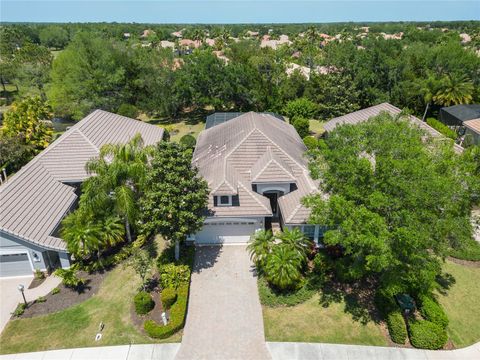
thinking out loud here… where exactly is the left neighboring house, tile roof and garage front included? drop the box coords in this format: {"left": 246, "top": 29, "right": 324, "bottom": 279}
{"left": 0, "top": 110, "right": 163, "bottom": 277}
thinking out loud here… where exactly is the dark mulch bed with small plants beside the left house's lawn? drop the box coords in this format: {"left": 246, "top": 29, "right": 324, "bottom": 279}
{"left": 20, "top": 271, "right": 107, "bottom": 318}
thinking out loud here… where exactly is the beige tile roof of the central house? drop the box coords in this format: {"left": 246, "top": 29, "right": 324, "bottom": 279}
{"left": 192, "top": 112, "right": 317, "bottom": 222}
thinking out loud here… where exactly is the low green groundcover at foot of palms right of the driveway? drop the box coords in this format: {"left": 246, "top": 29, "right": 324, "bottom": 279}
{"left": 258, "top": 278, "right": 315, "bottom": 307}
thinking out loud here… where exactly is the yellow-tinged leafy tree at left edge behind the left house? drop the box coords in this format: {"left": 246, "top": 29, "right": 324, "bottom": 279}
{"left": 1, "top": 96, "right": 53, "bottom": 154}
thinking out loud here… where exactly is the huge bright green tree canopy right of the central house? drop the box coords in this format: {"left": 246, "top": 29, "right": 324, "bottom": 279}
{"left": 304, "top": 114, "right": 480, "bottom": 294}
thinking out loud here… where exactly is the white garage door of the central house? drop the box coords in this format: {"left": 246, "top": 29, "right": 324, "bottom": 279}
{"left": 195, "top": 221, "right": 259, "bottom": 244}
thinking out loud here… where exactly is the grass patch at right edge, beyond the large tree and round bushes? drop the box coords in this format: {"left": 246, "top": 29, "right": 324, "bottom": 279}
{"left": 439, "top": 261, "right": 480, "bottom": 347}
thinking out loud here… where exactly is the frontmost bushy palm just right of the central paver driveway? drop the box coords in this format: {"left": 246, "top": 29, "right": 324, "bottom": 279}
{"left": 265, "top": 244, "right": 303, "bottom": 290}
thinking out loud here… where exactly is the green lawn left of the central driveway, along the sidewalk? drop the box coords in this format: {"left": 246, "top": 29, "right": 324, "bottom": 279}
{"left": 0, "top": 265, "right": 181, "bottom": 354}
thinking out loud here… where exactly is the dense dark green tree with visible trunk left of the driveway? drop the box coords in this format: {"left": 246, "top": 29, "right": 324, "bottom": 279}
{"left": 140, "top": 142, "right": 209, "bottom": 259}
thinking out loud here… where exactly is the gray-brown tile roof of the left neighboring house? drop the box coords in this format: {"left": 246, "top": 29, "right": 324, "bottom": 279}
{"left": 0, "top": 110, "right": 163, "bottom": 250}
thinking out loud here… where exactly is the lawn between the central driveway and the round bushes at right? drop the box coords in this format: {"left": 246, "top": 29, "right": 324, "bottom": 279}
{"left": 263, "top": 295, "right": 388, "bottom": 346}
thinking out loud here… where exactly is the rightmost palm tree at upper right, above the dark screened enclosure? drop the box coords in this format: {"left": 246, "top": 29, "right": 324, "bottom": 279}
{"left": 433, "top": 74, "right": 475, "bottom": 106}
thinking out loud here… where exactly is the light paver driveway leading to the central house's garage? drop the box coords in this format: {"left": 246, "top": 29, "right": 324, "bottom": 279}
{"left": 176, "top": 246, "right": 271, "bottom": 360}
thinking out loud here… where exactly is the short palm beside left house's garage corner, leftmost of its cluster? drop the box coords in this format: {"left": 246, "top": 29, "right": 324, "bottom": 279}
{"left": 61, "top": 210, "right": 102, "bottom": 258}
